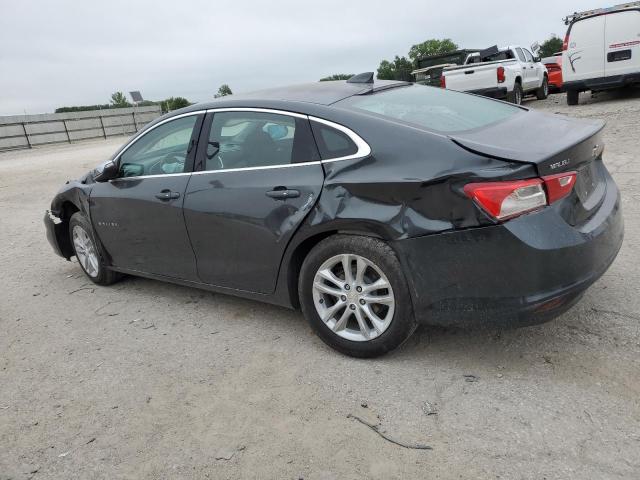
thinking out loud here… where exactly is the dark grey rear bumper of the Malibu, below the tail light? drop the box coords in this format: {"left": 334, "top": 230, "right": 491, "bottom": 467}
{"left": 394, "top": 167, "right": 624, "bottom": 325}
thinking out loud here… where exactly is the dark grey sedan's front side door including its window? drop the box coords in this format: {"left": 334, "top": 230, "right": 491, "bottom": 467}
{"left": 89, "top": 114, "right": 204, "bottom": 280}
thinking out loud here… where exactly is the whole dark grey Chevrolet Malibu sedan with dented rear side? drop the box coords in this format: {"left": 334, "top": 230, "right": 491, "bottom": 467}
{"left": 45, "top": 74, "right": 623, "bottom": 357}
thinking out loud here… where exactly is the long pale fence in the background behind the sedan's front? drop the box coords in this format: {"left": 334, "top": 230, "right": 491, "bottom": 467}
{"left": 0, "top": 106, "right": 162, "bottom": 151}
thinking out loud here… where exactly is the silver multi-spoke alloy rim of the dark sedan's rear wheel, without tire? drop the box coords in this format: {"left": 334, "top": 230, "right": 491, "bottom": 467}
{"left": 313, "top": 254, "right": 395, "bottom": 342}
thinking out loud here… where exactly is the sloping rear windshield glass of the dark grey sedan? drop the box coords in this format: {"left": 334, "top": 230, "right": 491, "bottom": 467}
{"left": 335, "top": 85, "right": 524, "bottom": 133}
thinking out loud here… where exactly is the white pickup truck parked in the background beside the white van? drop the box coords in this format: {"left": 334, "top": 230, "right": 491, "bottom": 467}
{"left": 440, "top": 46, "right": 549, "bottom": 105}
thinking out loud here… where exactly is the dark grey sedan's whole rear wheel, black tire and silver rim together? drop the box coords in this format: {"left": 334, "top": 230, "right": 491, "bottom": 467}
{"left": 298, "top": 235, "right": 417, "bottom": 358}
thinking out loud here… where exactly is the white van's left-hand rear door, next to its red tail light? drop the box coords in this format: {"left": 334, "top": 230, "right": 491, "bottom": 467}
{"left": 562, "top": 15, "right": 606, "bottom": 82}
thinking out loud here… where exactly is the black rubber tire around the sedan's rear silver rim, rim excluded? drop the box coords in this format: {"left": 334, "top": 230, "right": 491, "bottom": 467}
{"left": 298, "top": 235, "right": 417, "bottom": 358}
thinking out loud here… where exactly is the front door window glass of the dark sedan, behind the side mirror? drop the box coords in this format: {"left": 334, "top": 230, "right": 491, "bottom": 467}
{"left": 119, "top": 115, "right": 198, "bottom": 177}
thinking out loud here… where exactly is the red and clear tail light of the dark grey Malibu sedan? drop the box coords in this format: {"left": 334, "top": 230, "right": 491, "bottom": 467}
{"left": 464, "top": 172, "right": 576, "bottom": 220}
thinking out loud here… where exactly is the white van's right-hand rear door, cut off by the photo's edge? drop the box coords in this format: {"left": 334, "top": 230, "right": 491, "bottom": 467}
{"left": 605, "top": 10, "right": 640, "bottom": 77}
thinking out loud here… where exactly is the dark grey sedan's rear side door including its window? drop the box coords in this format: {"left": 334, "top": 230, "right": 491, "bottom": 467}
{"left": 184, "top": 109, "right": 324, "bottom": 293}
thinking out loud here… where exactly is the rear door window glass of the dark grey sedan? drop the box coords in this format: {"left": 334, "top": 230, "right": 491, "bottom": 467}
{"left": 204, "top": 111, "right": 319, "bottom": 170}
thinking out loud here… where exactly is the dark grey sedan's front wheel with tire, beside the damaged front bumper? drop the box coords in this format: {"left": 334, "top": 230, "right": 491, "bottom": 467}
{"left": 69, "top": 212, "right": 122, "bottom": 285}
